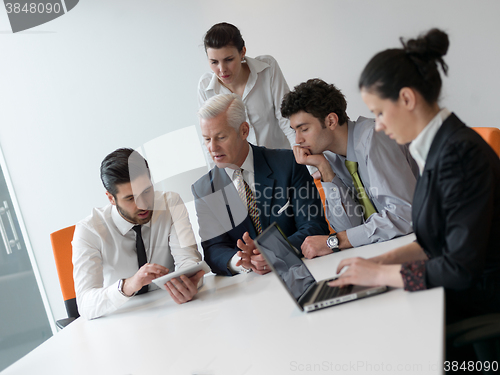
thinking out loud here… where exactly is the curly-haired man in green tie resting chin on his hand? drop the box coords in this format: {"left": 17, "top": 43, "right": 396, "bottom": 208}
{"left": 281, "top": 79, "right": 418, "bottom": 258}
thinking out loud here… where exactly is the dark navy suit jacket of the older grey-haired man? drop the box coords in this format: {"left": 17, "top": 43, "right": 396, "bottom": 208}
{"left": 191, "top": 145, "right": 328, "bottom": 275}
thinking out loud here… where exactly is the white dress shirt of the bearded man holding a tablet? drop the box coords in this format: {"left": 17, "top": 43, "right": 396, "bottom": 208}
{"left": 72, "top": 192, "right": 201, "bottom": 319}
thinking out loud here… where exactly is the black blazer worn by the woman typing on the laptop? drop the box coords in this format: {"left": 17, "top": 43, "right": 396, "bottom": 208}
{"left": 412, "top": 114, "right": 500, "bottom": 312}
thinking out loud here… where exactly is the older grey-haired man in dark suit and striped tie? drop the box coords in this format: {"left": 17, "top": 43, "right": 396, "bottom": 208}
{"left": 191, "top": 94, "right": 328, "bottom": 276}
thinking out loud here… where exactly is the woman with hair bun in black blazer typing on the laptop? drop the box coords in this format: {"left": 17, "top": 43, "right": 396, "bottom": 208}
{"left": 331, "top": 29, "right": 500, "bottom": 323}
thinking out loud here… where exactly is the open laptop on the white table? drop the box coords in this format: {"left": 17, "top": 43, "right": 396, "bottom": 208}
{"left": 255, "top": 223, "right": 387, "bottom": 312}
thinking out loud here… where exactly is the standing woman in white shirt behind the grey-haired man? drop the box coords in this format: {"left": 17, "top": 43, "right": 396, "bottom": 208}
{"left": 198, "top": 22, "right": 295, "bottom": 166}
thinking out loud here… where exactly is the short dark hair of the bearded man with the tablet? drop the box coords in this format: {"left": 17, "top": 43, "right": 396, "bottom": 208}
{"left": 101, "top": 148, "right": 150, "bottom": 199}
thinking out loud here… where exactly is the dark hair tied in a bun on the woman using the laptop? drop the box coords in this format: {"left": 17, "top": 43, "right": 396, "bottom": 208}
{"left": 359, "top": 29, "right": 450, "bottom": 104}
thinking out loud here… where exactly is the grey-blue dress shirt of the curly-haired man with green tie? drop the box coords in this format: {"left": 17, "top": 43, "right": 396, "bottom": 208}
{"left": 322, "top": 117, "right": 418, "bottom": 247}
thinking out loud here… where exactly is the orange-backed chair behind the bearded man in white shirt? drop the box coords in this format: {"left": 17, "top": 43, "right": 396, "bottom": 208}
{"left": 50, "top": 225, "right": 80, "bottom": 329}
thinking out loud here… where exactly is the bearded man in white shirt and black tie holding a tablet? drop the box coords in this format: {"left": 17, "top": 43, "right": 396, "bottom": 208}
{"left": 72, "top": 148, "right": 204, "bottom": 319}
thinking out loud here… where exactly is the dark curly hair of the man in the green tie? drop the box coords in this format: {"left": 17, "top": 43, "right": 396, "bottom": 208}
{"left": 281, "top": 78, "right": 349, "bottom": 127}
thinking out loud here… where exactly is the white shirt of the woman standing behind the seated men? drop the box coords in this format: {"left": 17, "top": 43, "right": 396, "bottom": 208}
{"left": 198, "top": 55, "right": 295, "bottom": 168}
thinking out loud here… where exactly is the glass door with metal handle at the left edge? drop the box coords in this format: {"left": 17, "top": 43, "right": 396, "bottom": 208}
{"left": 0, "top": 151, "right": 55, "bottom": 371}
